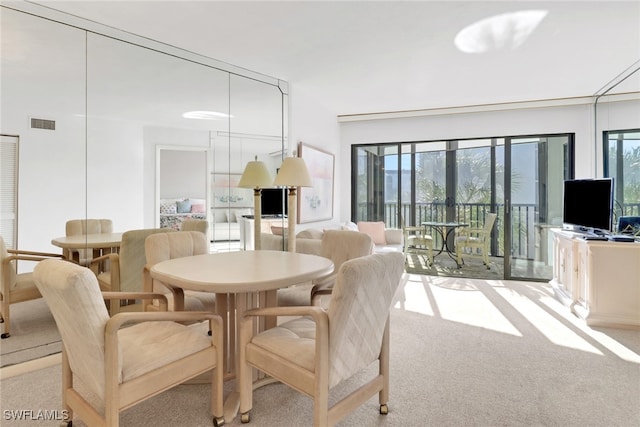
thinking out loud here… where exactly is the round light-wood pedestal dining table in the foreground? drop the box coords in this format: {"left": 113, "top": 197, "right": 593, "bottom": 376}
{"left": 150, "top": 250, "right": 334, "bottom": 420}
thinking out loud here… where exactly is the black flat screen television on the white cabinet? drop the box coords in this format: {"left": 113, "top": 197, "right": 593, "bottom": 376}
{"left": 562, "top": 178, "right": 614, "bottom": 234}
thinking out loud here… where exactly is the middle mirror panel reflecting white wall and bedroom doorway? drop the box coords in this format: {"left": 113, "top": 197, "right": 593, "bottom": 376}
{"left": 87, "top": 34, "right": 229, "bottom": 239}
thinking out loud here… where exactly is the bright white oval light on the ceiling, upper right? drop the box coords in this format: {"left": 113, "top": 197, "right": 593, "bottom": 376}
{"left": 454, "top": 10, "right": 548, "bottom": 53}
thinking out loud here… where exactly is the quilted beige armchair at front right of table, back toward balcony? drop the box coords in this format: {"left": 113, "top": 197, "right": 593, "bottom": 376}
{"left": 238, "top": 252, "right": 404, "bottom": 426}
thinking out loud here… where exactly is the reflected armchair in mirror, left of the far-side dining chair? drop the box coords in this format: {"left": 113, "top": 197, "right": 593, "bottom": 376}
{"left": 90, "top": 228, "right": 175, "bottom": 315}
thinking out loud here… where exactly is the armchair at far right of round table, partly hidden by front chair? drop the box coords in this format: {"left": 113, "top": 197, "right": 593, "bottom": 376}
{"left": 278, "top": 230, "right": 373, "bottom": 306}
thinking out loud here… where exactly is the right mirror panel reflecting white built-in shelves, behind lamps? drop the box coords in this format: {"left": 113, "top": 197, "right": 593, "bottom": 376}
{"left": 211, "top": 75, "right": 286, "bottom": 250}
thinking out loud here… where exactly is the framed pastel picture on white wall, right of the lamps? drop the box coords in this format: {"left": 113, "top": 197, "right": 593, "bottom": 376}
{"left": 298, "top": 142, "right": 334, "bottom": 224}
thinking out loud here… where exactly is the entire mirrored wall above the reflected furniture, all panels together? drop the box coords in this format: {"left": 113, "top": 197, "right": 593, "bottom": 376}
{"left": 0, "top": 6, "right": 288, "bottom": 252}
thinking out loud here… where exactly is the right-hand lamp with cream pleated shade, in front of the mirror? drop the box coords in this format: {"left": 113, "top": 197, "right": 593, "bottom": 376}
{"left": 273, "top": 157, "right": 312, "bottom": 252}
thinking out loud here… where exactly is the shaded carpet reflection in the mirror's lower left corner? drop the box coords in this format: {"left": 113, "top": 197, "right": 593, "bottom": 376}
{"left": 0, "top": 298, "right": 62, "bottom": 367}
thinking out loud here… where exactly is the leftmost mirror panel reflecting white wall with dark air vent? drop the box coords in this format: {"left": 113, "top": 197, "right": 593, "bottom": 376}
{"left": 0, "top": 8, "right": 86, "bottom": 251}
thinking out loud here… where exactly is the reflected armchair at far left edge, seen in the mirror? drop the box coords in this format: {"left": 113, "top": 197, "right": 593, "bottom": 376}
{"left": 0, "top": 236, "right": 63, "bottom": 339}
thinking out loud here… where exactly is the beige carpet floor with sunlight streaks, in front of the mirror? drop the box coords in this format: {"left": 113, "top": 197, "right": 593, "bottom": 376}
{"left": 0, "top": 275, "right": 640, "bottom": 427}
